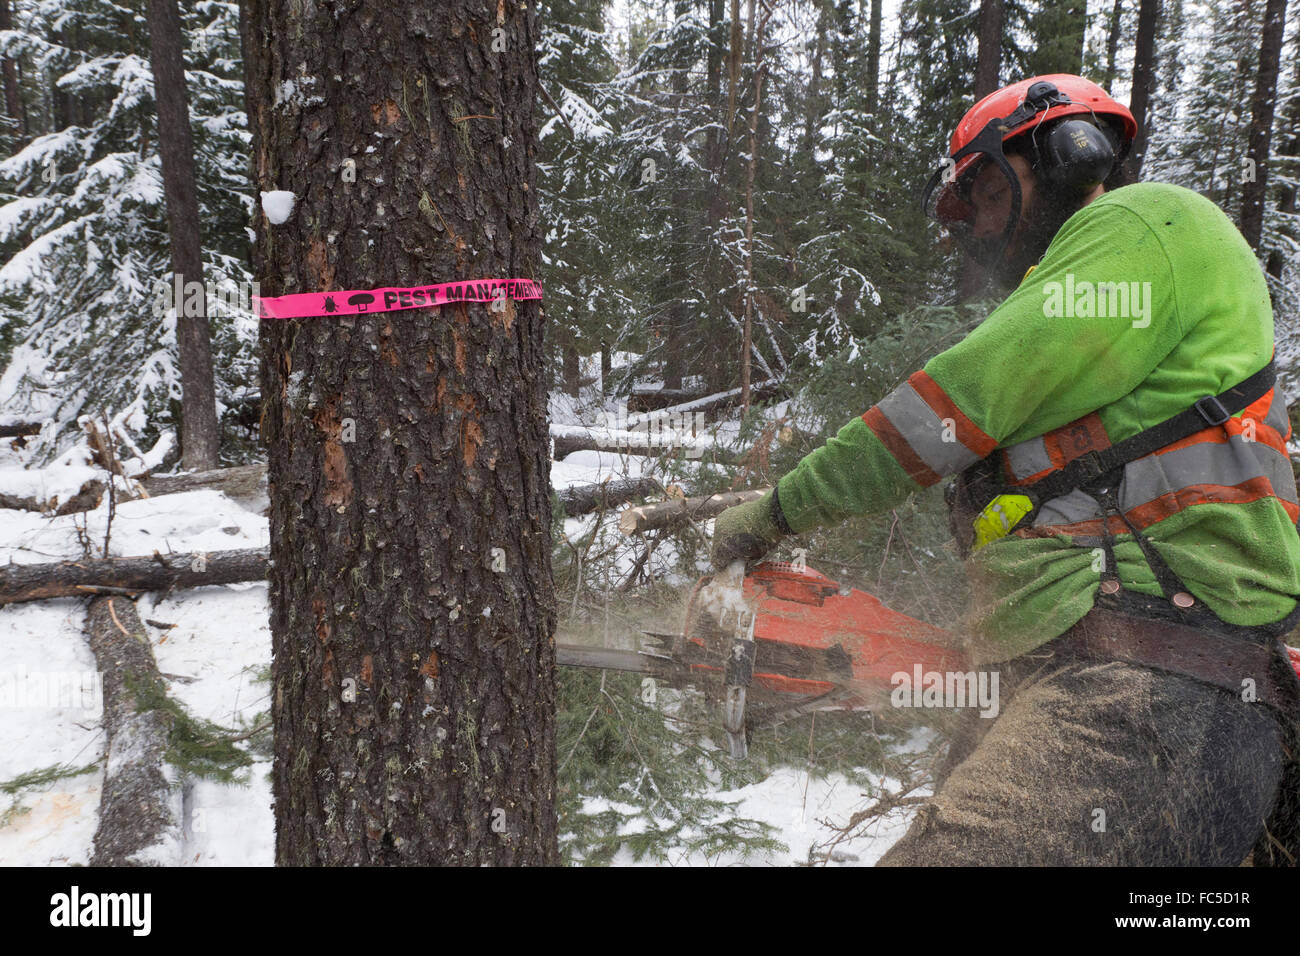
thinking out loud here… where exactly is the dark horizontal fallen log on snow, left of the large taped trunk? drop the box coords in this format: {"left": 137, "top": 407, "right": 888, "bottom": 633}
{"left": 0, "top": 548, "right": 270, "bottom": 605}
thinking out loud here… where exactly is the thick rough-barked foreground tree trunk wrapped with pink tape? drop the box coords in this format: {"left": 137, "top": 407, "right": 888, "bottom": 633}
{"left": 243, "top": 0, "right": 559, "bottom": 865}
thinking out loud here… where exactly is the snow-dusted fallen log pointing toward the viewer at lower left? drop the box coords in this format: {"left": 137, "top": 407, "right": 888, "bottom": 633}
{"left": 86, "top": 597, "right": 181, "bottom": 866}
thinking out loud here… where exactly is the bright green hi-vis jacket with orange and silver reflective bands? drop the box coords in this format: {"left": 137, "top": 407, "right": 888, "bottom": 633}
{"left": 779, "top": 183, "right": 1300, "bottom": 663}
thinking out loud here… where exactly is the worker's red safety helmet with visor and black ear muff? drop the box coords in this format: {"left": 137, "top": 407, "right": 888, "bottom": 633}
{"left": 922, "top": 73, "right": 1138, "bottom": 264}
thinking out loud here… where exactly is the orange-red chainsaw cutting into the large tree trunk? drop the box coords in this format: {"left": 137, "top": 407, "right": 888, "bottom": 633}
{"left": 556, "top": 562, "right": 1300, "bottom": 760}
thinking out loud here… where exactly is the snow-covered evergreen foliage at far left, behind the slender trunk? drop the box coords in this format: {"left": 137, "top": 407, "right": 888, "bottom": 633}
{"left": 0, "top": 0, "right": 256, "bottom": 464}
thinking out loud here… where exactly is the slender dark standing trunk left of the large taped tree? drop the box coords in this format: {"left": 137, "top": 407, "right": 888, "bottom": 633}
{"left": 148, "top": 0, "right": 217, "bottom": 471}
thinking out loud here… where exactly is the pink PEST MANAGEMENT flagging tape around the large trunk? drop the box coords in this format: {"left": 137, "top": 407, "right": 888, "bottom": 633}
{"left": 254, "top": 278, "right": 542, "bottom": 319}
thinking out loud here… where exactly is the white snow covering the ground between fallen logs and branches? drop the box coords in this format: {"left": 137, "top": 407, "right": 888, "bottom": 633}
{"left": 0, "top": 382, "right": 907, "bottom": 866}
